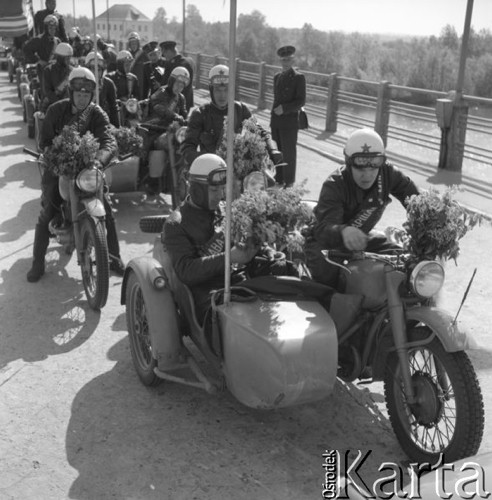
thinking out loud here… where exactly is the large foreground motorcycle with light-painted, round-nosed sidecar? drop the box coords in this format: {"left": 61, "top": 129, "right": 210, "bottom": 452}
{"left": 121, "top": 176, "right": 484, "bottom": 464}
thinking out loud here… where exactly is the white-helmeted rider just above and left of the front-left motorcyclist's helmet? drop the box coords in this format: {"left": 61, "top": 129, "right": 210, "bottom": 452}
{"left": 40, "top": 42, "right": 73, "bottom": 113}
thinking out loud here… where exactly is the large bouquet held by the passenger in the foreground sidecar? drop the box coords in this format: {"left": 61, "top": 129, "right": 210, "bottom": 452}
{"left": 231, "top": 185, "right": 312, "bottom": 252}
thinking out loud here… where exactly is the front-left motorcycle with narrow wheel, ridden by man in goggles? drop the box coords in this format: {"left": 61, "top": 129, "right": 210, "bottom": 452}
{"left": 24, "top": 148, "right": 129, "bottom": 310}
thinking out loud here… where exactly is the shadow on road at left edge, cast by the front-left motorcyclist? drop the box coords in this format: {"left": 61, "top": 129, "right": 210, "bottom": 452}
{"left": 0, "top": 251, "right": 100, "bottom": 370}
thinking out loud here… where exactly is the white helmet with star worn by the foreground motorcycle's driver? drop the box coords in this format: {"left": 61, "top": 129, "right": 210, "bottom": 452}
{"left": 343, "top": 128, "right": 386, "bottom": 168}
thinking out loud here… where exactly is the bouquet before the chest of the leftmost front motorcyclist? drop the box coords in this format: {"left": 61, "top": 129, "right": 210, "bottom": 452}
{"left": 44, "top": 125, "right": 99, "bottom": 179}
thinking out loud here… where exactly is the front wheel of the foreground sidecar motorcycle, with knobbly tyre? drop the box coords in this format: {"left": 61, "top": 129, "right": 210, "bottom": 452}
{"left": 384, "top": 327, "right": 484, "bottom": 464}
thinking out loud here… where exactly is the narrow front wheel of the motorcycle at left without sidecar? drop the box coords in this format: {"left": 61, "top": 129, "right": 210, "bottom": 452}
{"left": 80, "top": 217, "right": 109, "bottom": 310}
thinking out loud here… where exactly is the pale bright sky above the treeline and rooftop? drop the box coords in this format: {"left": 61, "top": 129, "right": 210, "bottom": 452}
{"left": 49, "top": 0, "right": 492, "bottom": 36}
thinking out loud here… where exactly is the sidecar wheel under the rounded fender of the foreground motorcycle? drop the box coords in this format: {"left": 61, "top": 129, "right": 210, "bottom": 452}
{"left": 125, "top": 272, "right": 162, "bottom": 386}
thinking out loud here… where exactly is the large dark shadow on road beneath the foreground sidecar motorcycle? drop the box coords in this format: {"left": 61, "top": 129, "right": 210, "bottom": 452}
{"left": 66, "top": 336, "right": 404, "bottom": 500}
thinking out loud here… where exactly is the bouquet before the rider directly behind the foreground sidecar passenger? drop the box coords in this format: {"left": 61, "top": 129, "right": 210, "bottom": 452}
{"left": 217, "top": 117, "right": 273, "bottom": 182}
